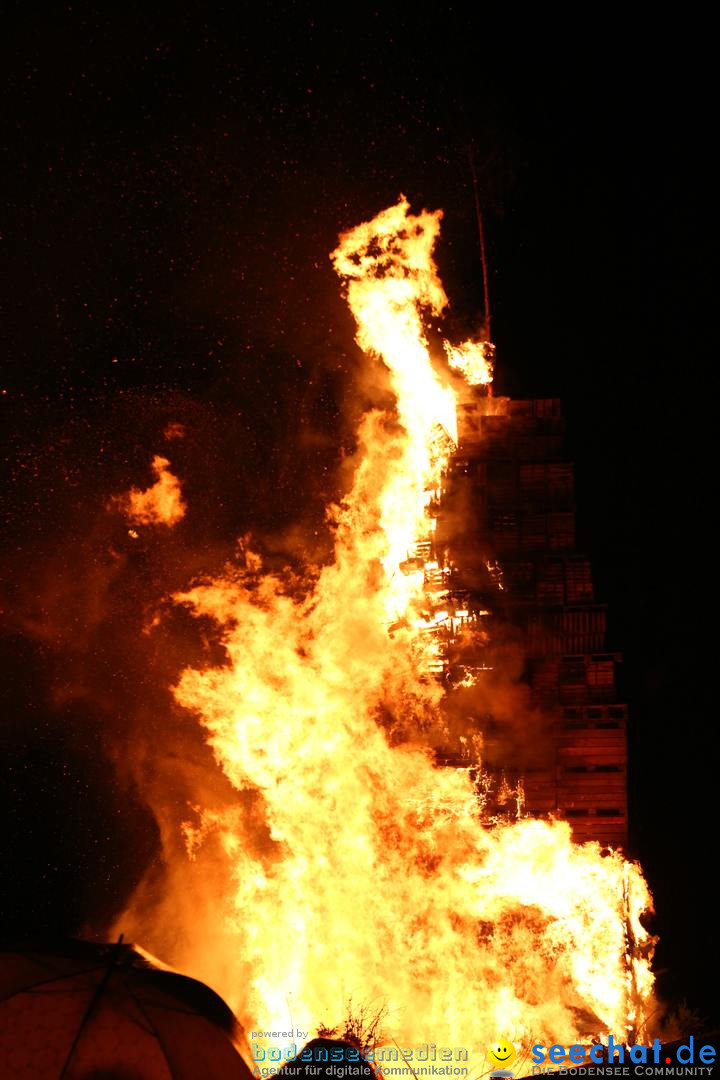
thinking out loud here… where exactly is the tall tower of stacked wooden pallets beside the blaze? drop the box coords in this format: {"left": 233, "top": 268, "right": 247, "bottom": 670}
{"left": 438, "top": 397, "right": 627, "bottom": 847}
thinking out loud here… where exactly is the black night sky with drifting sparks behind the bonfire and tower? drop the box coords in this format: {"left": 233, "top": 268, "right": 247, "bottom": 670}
{"left": 0, "top": 10, "right": 720, "bottom": 1022}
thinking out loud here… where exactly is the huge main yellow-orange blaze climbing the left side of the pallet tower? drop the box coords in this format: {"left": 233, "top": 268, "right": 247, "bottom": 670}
{"left": 143, "top": 199, "right": 652, "bottom": 1059}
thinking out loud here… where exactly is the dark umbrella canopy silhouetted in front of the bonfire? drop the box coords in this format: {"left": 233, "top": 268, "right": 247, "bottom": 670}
{"left": 0, "top": 942, "right": 252, "bottom": 1080}
